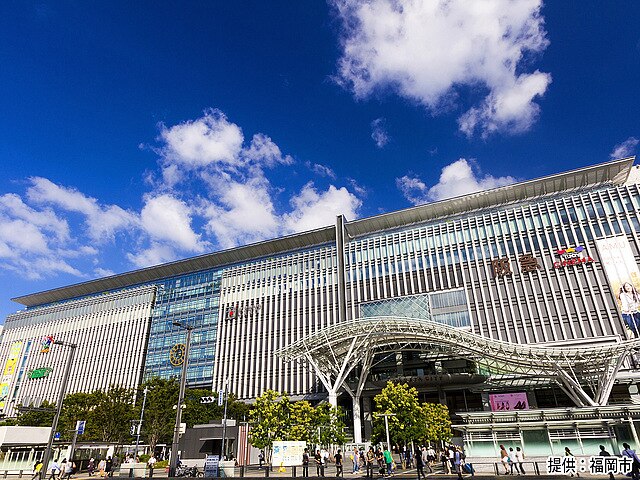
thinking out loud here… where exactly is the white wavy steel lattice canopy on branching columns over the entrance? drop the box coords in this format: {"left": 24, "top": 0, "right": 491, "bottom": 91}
{"left": 276, "top": 316, "right": 640, "bottom": 406}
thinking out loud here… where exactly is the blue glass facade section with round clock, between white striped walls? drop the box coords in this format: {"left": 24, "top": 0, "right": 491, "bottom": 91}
{"left": 144, "top": 270, "right": 222, "bottom": 388}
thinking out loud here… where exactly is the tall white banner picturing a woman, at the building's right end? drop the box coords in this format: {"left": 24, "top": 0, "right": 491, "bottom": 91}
{"left": 596, "top": 235, "right": 640, "bottom": 337}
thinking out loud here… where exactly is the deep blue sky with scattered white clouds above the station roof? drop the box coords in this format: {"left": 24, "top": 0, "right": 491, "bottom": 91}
{"left": 0, "top": 0, "right": 640, "bottom": 318}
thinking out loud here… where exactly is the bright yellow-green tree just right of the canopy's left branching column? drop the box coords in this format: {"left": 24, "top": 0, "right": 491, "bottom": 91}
{"left": 373, "top": 382, "right": 427, "bottom": 445}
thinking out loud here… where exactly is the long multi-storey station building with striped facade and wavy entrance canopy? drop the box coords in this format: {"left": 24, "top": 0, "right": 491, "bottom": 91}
{"left": 0, "top": 157, "right": 640, "bottom": 456}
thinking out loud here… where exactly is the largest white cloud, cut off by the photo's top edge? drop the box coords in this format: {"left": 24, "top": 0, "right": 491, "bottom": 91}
{"left": 333, "top": 0, "right": 551, "bottom": 136}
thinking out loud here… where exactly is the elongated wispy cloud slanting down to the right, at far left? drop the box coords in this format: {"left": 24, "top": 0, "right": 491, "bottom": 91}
{"left": 27, "top": 177, "right": 137, "bottom": 242}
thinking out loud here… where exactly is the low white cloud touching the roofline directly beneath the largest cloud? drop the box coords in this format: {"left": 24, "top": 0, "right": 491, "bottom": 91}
{"left": 396, "top": 158, "right": 516, "bottom": 205}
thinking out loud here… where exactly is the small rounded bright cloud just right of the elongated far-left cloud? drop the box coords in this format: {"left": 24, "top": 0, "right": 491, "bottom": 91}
{"left": 140, "top": 194, "right": 207, "bottom": 253}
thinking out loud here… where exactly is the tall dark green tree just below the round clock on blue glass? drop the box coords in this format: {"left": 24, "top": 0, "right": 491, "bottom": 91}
{"left": 137, "top": 377, "right": 180, "bottom": 451}
